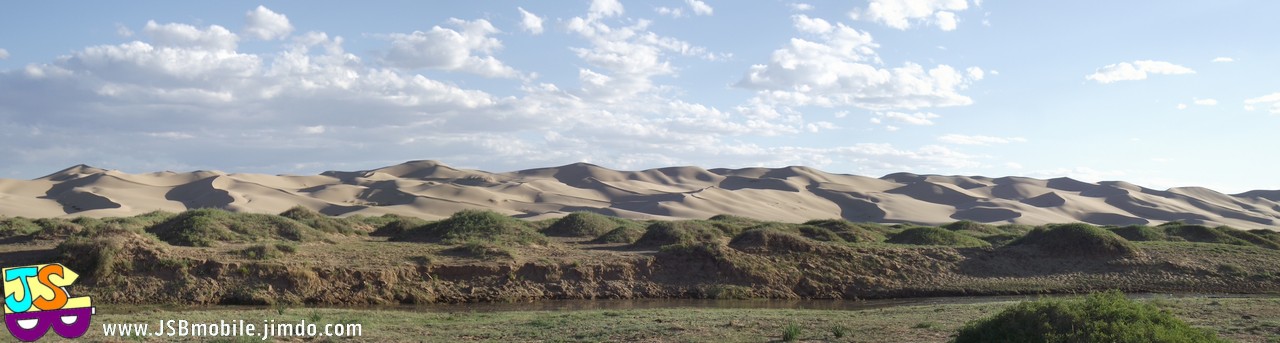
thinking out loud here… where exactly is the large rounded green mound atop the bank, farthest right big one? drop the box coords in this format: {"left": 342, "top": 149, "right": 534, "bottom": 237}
{"left": 1009, "top": 223, "right": 1142, "bottom": 257}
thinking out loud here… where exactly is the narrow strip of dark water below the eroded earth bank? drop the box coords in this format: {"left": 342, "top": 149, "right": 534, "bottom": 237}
{"left": 102, "top": 293, "right": 1280, "bottom": 314}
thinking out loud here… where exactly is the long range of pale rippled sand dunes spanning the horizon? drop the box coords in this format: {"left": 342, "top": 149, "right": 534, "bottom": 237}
{"left": 0, "top": 160, "right": 1280, "bottom": 229}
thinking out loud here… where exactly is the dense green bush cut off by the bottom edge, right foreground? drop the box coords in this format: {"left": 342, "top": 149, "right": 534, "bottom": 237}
{"left": 954, "top": 291, "right": 1225, "bottom": 343}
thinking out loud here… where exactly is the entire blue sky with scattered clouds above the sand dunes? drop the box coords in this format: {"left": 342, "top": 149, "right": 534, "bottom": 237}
{"left": 0, "top": 0, "right": 1280, "bottom": 193}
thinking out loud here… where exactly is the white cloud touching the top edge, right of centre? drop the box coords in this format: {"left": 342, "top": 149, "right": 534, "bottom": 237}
{"left": 850, "top": 0, "right": 969, "bottom": 31}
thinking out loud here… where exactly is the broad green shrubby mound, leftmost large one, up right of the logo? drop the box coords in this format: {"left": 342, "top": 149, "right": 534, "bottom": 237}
{"left": 147, "top": 209, "right": 321, "bottom": 247}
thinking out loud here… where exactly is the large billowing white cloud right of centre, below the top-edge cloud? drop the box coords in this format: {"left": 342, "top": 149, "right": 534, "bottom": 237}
{"left": 735, "top": 14, "right": 977, "bottom": 110}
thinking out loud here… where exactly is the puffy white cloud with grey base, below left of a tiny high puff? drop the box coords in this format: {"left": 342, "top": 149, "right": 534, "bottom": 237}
{"left": 381, "top": 18, "right": 520, "bottom": 78}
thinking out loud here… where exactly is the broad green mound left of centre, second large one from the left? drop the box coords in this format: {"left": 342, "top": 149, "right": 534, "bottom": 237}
{"left": 392, "top": 210, "right": 548, "bottom": 246}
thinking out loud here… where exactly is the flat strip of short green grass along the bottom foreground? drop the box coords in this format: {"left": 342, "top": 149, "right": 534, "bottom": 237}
{"left": 32, "top": 298, "right": 1280, "bottom": 342}
